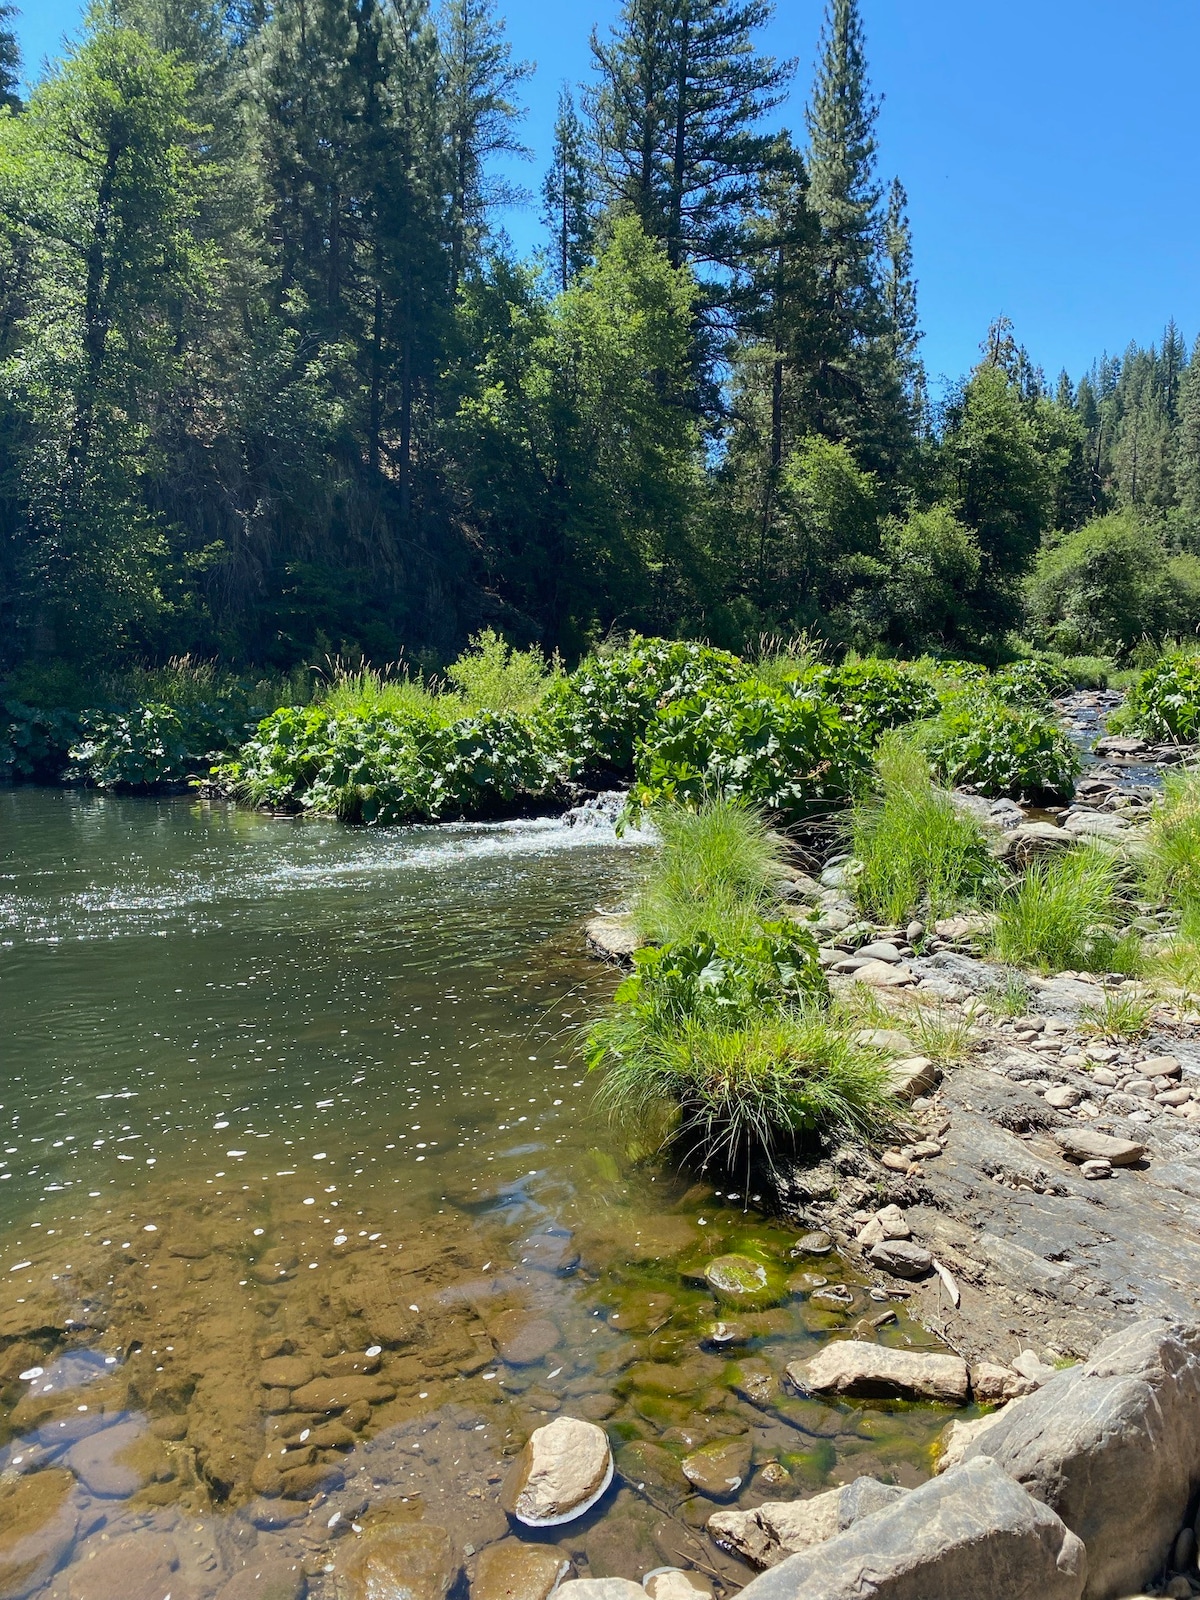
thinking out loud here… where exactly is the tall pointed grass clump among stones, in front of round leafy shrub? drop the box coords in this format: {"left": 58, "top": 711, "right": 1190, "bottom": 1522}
{"left": 850, "top": 733, "right": 997, "bottom": 925}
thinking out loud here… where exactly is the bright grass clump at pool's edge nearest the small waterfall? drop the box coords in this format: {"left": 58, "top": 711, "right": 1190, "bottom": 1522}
{"left": 634, "top": 795, "right": 784, "bottom": 942}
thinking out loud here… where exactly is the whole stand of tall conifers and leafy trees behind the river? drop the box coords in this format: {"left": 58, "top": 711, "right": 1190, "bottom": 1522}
{"left": 0, "top": 0, "right": 1200, "bottom": 672}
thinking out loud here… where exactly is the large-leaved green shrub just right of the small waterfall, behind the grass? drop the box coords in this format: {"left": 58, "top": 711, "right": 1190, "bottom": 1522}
{"left": 630, "top": 682, "right": 869, "bottom": 822}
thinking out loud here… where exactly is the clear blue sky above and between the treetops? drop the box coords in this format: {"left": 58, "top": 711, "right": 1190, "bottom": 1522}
{"left": 11, "top": 0, "right": 1200, "bottom": 382}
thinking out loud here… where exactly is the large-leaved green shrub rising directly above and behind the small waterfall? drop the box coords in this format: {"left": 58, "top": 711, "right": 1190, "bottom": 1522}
{"left": 538, "top": 637, "right": 746, "bottom": 778}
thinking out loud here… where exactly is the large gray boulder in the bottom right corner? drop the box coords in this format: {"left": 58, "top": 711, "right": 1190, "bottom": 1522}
{"left": 947, "top": 1317, "right": 1200, "bottom": 1600}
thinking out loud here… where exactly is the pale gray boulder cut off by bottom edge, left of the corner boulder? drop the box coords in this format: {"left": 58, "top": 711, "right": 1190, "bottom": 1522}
{"left": 741, "top": 1458, "right": 1088, "bottom": 1600}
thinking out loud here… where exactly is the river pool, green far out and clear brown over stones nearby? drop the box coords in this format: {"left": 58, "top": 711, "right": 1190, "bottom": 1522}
{"left": 0, "top": 790, "right": 946, "bottom": 1600}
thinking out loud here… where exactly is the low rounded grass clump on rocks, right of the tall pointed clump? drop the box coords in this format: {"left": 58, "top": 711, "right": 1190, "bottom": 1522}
{"left": 994, "top": 845, "right": 1142, "bottom": 974}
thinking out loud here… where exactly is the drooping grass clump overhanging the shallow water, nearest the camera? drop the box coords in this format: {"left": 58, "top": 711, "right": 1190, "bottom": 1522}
{"left": 598, "top": 1006, "right": 898, "bottom": 1170}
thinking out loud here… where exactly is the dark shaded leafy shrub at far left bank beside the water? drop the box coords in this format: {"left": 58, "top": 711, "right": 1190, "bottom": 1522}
{"left": 70, "top": 701, "right": 254, "bottom": 789}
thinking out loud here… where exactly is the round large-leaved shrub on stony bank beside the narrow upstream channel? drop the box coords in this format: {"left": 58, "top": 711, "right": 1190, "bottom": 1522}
{"left": 920, "top": 690, "right": 1080, "bottom": 795}
